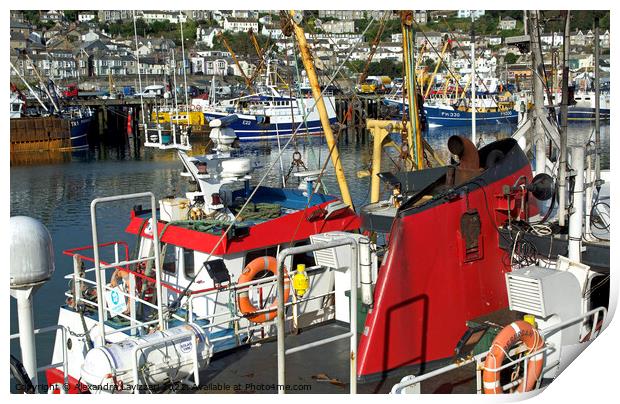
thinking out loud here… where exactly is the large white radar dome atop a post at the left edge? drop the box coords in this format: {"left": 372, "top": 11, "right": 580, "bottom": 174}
{"left": 9, "top": 216, "right": 54, "bottom": 288}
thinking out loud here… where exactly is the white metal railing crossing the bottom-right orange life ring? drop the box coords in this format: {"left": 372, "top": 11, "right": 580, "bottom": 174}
{"left": 391, "top": 307, "right": 607, "bottom": 394}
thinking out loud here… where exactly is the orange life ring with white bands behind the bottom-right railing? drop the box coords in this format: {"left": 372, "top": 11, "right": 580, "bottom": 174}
{"left": 482, "top": 320, "right": 545, "bottom": 394}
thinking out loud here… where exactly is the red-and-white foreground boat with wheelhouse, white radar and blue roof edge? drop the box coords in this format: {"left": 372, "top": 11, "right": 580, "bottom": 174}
{"left": 35, "top": 117, "right": 359, "bottom": 392}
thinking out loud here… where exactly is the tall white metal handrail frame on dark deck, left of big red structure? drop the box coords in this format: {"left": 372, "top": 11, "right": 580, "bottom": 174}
{"left": 276, "top": 237, "right": 359, "bottom": 394}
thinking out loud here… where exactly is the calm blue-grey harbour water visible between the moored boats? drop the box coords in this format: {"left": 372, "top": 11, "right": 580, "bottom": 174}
{"left": 11, "top": 124, "right": 609, "bottom": 376}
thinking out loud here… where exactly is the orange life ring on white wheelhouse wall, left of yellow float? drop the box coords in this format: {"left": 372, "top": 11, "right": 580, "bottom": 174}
{"left": 237, "top": 256, "right": 290, "bottom": 323}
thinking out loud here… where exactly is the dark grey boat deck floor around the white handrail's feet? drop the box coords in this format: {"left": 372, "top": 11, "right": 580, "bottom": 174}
{"left": 194, "top": 322, "right": 476, "bottom": 394}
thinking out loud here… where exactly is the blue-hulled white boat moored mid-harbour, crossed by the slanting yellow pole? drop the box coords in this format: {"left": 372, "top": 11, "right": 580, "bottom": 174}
{"left": 203, "top": 87, "right": 337, "bottom": 141}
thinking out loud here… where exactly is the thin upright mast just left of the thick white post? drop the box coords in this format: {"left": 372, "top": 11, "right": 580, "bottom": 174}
{"left": 558, "top": 10, "right": 570, "bottom": 226}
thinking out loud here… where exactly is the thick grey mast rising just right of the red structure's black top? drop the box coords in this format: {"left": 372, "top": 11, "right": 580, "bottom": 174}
{"left": 530, "top": 10, "right": 553, "bottom": 174}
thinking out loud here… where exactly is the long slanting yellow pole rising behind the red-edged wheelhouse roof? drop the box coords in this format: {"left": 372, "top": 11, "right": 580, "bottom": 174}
{"left": 289, "top": 10, "right": 353, "bottom": 208}
